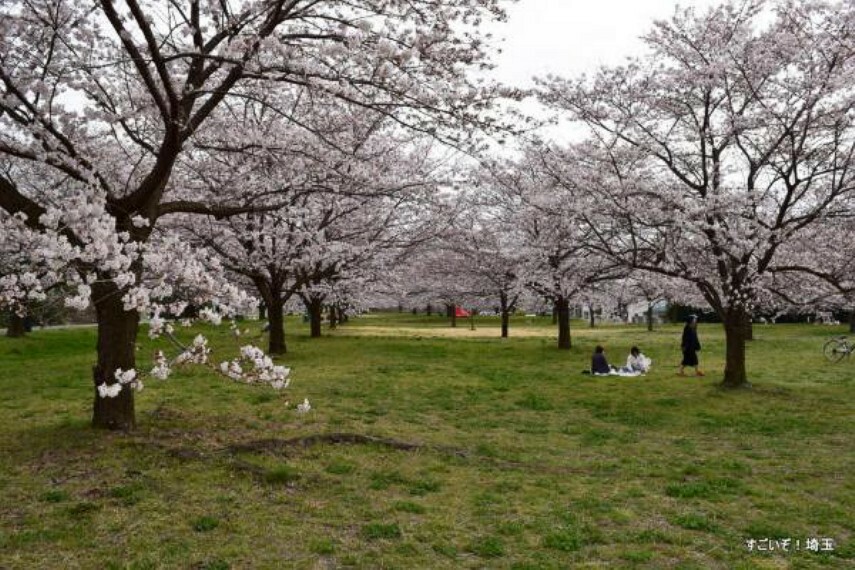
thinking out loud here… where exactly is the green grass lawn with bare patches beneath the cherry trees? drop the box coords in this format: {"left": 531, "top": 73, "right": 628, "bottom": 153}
{"left": 0, "top": 314, "right": 855, "bottom": 569}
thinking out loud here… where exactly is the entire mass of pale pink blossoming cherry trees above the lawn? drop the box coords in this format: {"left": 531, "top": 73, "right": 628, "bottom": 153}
{"left": 0, "top": 0, "right": 855, "bottom": 429}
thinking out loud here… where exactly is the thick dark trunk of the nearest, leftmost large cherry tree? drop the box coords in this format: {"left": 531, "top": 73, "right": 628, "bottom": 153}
{"left": 92, "top": 281, "right": 140, "bottom": 431}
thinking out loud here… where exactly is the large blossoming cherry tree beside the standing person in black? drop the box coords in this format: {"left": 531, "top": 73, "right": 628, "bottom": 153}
{"left": 541, "top": 1, "right": 855, "bottom": 387}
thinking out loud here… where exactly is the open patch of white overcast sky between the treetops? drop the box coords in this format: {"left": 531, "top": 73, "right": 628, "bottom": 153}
{"left": 494, "top": 0, "right": 721, "bottom": 86}
